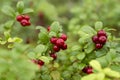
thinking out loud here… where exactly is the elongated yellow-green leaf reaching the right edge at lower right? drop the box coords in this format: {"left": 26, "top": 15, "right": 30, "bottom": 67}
{"left": 104, "top": 68, "right": 120, "bottom": 78}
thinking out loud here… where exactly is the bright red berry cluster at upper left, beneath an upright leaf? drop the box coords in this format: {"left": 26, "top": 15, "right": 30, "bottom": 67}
{"left": 16, "top": 15, "right": 31, "bottom": 26}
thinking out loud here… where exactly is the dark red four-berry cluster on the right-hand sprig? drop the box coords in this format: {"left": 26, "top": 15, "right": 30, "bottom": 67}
{"left": 92, "top": 30, "right": 107, "bottom": 49}
